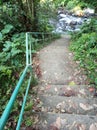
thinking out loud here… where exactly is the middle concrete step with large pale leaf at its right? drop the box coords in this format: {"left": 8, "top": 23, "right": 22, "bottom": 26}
{"left": 34, "top": 95, "right": 97, "bottom": 115}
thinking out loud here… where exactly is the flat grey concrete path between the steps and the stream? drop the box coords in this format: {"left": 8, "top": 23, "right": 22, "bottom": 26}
{"left": 39, "top": 35, "right": 86, "bottom": 85}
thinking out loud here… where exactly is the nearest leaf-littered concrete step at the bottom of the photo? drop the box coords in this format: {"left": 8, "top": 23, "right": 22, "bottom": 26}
{"left": 32, "top": 113, "right": 97, "bottom": 130}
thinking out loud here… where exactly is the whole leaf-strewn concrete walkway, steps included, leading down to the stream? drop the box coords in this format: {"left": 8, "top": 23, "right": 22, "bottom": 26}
{"left": 26, "top": 35, "right": 97, "bottom": 130}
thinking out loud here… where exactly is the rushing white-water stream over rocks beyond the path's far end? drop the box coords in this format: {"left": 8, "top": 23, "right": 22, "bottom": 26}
{"left": 49, "top": 8, "right": 95, "bottom": 33}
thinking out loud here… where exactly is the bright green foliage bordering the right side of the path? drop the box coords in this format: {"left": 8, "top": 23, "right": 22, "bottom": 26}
{"left": 70, "top": 19, "right": 97, "bottom": 85}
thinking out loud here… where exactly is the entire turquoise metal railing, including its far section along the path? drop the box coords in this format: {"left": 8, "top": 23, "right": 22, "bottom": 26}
{"left": 0, "top": 32, "right": 59, "bottom": 130}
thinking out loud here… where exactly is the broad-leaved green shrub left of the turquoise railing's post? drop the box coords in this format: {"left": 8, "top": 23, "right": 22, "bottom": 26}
{"left": 0, "top": 24, "right": 25, "bottom": 113}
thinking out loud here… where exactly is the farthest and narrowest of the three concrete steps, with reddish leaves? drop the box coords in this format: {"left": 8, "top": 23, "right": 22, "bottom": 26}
{"left": 38, "top": 84, "right": 95, "bottom": 97}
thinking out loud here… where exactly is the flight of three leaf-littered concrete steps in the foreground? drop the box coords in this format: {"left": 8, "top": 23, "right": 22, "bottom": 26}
{"left": 33, "top": 85, "right": 97, "bottom": 130}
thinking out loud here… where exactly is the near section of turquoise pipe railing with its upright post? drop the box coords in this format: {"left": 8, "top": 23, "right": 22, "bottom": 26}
{"left": 0, "top": 33, "right": 32, "bottom": 130}
